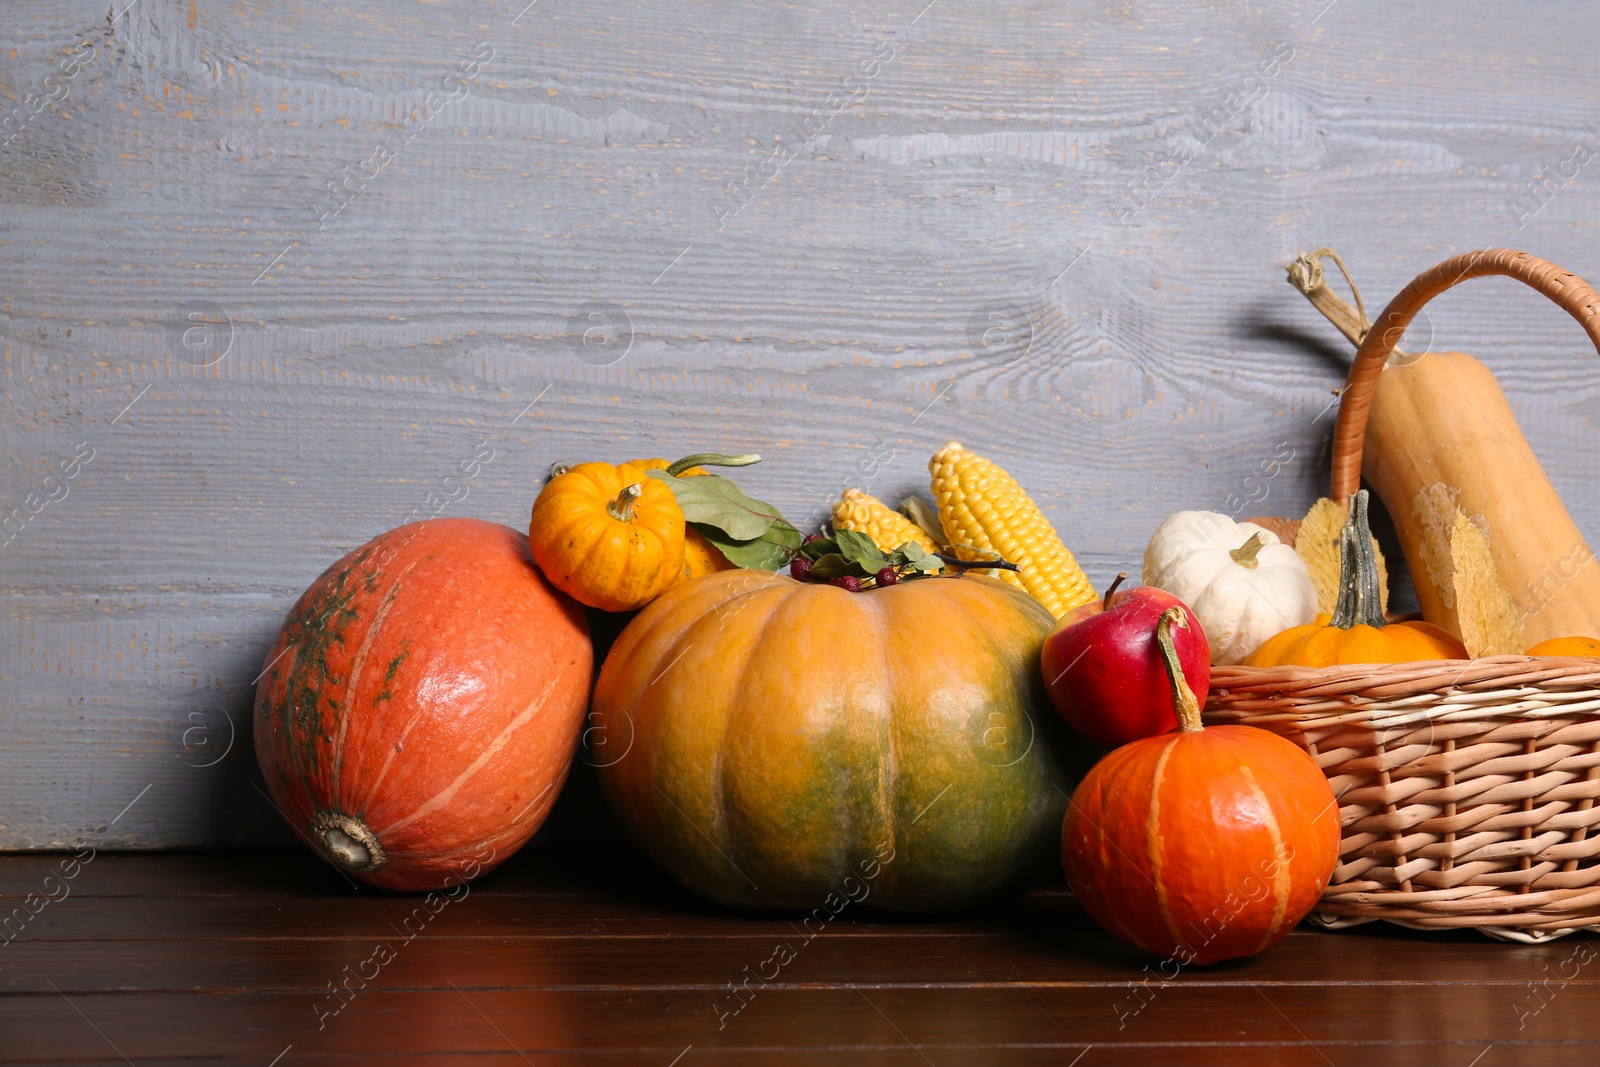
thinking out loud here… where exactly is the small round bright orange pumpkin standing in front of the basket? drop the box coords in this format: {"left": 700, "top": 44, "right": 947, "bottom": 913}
{"left": 1061, "top": 608, "right": 1339, "bottom": 965}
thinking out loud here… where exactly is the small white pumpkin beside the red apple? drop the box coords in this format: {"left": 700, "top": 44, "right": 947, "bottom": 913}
{"left": 1144, "top": 512, "right": 1317, "bottom": 664}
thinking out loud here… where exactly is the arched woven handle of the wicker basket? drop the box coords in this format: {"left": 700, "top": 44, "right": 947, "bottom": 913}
{"left": 1330, "top": 248, "right": 1600, "bottom": 507}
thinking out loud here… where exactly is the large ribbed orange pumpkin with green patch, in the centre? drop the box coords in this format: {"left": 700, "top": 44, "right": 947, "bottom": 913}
{"left": 594, "top": 569, "right": 1069, "bottom": 910}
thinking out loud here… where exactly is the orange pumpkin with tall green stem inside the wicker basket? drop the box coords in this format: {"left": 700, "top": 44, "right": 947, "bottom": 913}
{"left": 1245, "top": 490, "right": 1467, "bottom": 667}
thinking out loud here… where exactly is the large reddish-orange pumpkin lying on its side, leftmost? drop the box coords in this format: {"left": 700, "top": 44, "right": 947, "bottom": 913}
{"left": 254, "top": 518, "right": 594, "bottom": 889}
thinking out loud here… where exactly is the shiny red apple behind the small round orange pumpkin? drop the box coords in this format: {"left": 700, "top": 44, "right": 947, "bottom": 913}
{"left": 1042, "top": 574, "right": 1211, "bottom": 749}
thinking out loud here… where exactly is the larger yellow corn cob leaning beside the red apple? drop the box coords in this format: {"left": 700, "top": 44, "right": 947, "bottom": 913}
{"left": 928, "top": 442, "right": 1096, "bottom": 619}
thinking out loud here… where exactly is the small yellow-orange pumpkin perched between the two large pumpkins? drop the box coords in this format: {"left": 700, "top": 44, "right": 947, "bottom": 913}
{"left": 528, "top": 462, "right": 685, "bottom": 611}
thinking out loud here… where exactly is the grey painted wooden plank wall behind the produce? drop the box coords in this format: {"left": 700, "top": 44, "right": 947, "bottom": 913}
{"left": 0, "top": 0, "right": 1600, "bottom": 848}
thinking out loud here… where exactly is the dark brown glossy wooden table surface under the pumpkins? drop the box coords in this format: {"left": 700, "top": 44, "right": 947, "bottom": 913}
{"left": 0, "top": 843, "right": 1600, "bottom": 1067}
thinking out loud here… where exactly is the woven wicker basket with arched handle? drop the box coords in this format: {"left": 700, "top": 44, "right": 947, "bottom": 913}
{"left": 1205, "top": 250, "right": 1600, "bottom": 942}
